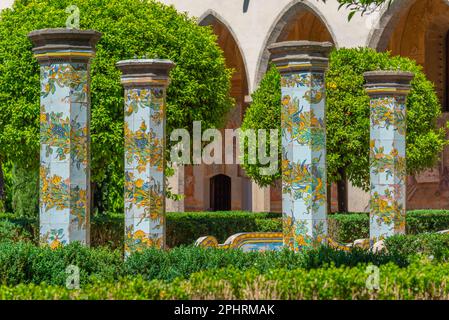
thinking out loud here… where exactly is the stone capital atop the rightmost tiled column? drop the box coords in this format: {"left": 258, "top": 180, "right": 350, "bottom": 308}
{"left": 363, "top": 70, "right": 415, "bottom": 97}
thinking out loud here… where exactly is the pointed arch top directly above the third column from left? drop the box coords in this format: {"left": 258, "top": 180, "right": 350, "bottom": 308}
{"left": 254, "top": 0, "right": 336, "bottom": 88}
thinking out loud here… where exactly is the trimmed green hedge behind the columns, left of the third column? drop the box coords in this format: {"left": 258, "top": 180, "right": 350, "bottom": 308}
{"left": 0, "top": 211, "right": 282, "bottom": 248}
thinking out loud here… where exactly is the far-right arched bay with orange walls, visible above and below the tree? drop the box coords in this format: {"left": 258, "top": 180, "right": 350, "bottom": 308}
{"left": 369, "top": 0, "right": 449, "bottom": 209}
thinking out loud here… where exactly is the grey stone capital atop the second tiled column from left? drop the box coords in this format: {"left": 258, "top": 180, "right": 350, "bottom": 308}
{"left": 117, "top": 59, "right": 175, "bottom": 88}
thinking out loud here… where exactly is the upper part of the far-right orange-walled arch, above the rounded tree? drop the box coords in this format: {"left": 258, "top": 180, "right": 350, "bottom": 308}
{"left": 368, "top": 0, "right": 449, "bottom": 111}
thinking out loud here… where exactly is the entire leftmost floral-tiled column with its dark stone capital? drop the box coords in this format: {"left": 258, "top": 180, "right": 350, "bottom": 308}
{"left": 28, "top": 29, "right": 101, "bottom": 247}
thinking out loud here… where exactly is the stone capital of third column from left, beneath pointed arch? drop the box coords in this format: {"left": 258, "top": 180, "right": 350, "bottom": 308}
{"left": 268, "top": 41, "right": 334, "bottom": 73}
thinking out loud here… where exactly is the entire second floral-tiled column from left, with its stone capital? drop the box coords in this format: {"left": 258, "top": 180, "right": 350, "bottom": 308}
{"left": 117, "top": 59, "right": 174, "bottom": 255}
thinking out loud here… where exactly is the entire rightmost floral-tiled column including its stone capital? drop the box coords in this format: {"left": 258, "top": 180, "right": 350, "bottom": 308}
{"left": 364, "top": 71, "right": 414, "bottom": 244}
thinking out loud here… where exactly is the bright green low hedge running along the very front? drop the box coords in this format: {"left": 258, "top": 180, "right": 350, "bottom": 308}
{"left": 0, "top": 262, "right": 449, "bottom": 300}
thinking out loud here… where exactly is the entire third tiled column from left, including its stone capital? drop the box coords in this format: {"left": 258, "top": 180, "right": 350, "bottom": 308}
{"left": 269, "top": 41, "right": 332, "bottom": 251}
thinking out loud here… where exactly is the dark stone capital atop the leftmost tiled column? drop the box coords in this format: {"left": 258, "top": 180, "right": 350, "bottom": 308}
{"left": 28, "top": 28, "right": 102, "bottom": 64}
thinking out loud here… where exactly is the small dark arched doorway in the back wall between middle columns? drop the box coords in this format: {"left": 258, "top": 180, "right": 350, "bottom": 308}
{"left": 210, "top": 174, "right": 231, "bottom": 211}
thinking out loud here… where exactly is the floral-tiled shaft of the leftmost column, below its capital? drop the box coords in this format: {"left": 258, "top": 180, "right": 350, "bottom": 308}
{"left": 40, "top": 63, "right": 90, "bottom": 247}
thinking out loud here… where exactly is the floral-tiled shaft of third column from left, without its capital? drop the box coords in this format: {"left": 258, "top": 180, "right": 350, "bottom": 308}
{"left": 281, "top": 72, "right": 327, "bottom": 250}
